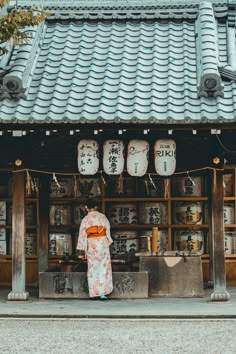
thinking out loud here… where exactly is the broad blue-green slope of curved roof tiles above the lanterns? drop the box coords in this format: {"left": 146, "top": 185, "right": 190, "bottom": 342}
{"left": 0, "top": 0, "right": 236, "bottom": 124}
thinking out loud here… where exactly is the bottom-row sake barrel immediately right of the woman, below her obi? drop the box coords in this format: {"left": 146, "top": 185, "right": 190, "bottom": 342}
{"left": 111, "top": 230, "right": 138, "bottom": 256}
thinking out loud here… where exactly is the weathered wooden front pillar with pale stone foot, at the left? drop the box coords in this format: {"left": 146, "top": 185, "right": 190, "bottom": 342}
{"left": 8, "top": 172, "right": 29, "bottom": 300}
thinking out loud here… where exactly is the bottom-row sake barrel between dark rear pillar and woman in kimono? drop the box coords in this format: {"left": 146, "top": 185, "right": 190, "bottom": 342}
{"left": 49, "top": 233, "right": 72, "bottom": 256}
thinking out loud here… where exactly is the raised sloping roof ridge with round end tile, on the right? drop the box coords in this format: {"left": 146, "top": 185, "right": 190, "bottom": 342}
{"left": 196, "top": 1, "right": 224, "bottom": 97}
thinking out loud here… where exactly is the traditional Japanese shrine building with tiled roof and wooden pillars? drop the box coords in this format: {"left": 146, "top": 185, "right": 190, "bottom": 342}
{"left": 0, "top": 0, "right": 236, "bottom": 300}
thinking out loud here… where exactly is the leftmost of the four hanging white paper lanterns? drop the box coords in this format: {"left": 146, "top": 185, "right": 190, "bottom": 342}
{"left": 78, "top": 140, "right": 99, "bottom": 175}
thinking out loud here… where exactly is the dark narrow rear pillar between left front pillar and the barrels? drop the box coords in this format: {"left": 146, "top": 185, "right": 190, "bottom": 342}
{"left": 38, "top": 175, "right": 50, "bottom": 272}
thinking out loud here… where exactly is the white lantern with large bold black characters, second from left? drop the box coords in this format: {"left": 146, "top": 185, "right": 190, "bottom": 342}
{"left": 103, "top": 140, "right": 125, "bottom": 175}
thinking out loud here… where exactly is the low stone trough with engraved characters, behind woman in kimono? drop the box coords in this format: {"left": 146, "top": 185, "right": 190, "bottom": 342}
{"left": 39, "top": 272, "right": 148, "bottom": 299}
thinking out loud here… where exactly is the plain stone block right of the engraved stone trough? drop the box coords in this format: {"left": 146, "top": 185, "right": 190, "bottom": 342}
{"left": 139, "top": 256, "right": 204, "bottom": 297}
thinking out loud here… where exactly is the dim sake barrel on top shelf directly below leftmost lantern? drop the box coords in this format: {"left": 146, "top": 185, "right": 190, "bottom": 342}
{"left": 77, "top": 178, "right": 101, "bottom": 198}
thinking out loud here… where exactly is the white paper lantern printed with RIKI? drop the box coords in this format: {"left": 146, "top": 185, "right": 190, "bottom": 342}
{"left": 154, "top": 139, "right": 176, "bottom": 176}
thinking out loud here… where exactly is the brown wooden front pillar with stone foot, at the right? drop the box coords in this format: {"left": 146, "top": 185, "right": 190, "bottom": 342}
{"left": 211, "top": 170, "right": 230, "bottom": 301}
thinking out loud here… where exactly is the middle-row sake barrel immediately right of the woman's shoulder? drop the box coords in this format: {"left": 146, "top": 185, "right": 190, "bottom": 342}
{"left": 108, "top": 203, "right": 137, "bottom": 224}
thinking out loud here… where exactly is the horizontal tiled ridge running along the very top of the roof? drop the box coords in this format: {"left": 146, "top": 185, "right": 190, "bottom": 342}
{"left": 10, "top": 0, "right": 228, "bottom": 20}
